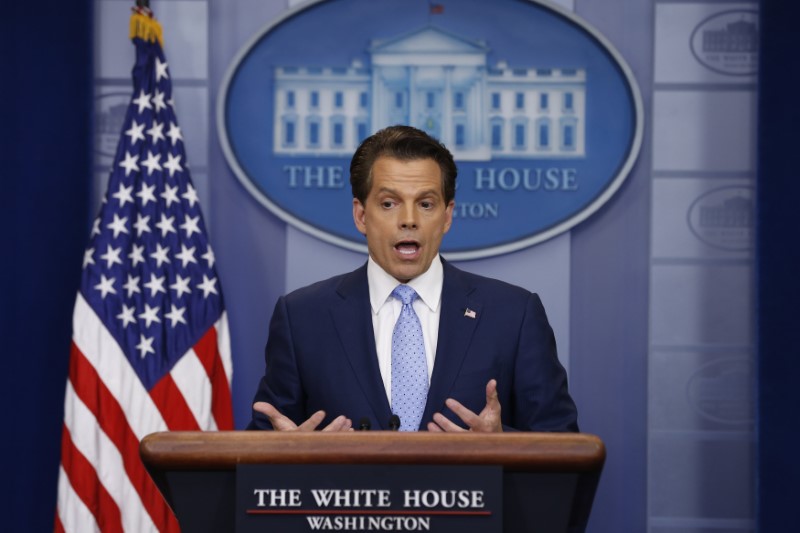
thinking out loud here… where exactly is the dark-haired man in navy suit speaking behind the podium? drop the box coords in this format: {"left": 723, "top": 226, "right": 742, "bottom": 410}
{"left": 250, "top": 126, "right": 578, "bottom": 432}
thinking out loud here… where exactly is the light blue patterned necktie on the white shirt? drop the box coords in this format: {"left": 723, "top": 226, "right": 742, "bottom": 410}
{"left": 392, "top": 285, "right": 428, "bottom": 431}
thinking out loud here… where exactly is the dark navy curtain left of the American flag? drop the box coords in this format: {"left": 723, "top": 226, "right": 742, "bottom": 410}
{"left": 0, "top": 0, "right": 92, "bottom": 531}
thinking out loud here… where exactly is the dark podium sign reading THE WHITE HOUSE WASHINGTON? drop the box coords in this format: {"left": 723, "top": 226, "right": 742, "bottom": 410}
{"left": 236, "top": 465, "right": 503, "bottom": 533}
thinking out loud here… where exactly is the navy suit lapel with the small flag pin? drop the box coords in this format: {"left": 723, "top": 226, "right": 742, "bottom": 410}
{"left": 422, "top": 261, "right": 481, "bottom": 424}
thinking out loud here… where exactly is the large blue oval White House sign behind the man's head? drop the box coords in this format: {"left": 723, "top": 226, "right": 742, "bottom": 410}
{"left": 217, "top": 0, "right": 643, "bottom": 260}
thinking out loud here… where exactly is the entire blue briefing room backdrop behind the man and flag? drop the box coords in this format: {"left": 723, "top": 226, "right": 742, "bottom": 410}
{"left": 0, "top": 0, "right": 800, "bottom": 533}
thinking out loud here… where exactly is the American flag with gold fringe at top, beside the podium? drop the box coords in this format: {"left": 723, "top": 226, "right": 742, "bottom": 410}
{"left": 55, "top": 8, "right": 233, "bottom": 532}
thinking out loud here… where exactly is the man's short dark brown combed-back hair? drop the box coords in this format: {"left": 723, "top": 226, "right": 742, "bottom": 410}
{"left": 350, "top": 125, "right": 458, "bottom": 205}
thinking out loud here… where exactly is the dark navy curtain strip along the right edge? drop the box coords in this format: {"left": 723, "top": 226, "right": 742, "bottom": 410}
{"left": 757, "top": 0, "right": 800, "bottom": 532}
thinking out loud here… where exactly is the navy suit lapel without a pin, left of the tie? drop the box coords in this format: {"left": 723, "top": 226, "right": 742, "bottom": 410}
{"left": 331, "top": 265, "right": 392, "bottom": 429}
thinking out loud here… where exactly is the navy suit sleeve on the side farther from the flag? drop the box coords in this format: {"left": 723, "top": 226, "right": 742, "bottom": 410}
{"left": 516, "top": 294, "right": 578, "bottom": 431}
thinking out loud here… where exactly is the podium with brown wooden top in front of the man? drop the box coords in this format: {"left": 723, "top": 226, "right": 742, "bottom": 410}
{"left": 140, "top": 431, "right": 605, "bottom": 533}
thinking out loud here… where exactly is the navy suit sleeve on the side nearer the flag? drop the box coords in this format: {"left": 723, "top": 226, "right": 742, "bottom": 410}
{"left": 247, "top": 297, "right": 307, "bottom": 429}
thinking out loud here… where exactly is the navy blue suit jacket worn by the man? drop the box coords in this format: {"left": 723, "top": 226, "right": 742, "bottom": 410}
{"left": 249, "top": 261, "right": 578, "bottom": 431}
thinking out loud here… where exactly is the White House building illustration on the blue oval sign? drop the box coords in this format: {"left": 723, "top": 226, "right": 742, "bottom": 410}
{"left": 273, "top": 26, "right": 586, "bottom": 161}
